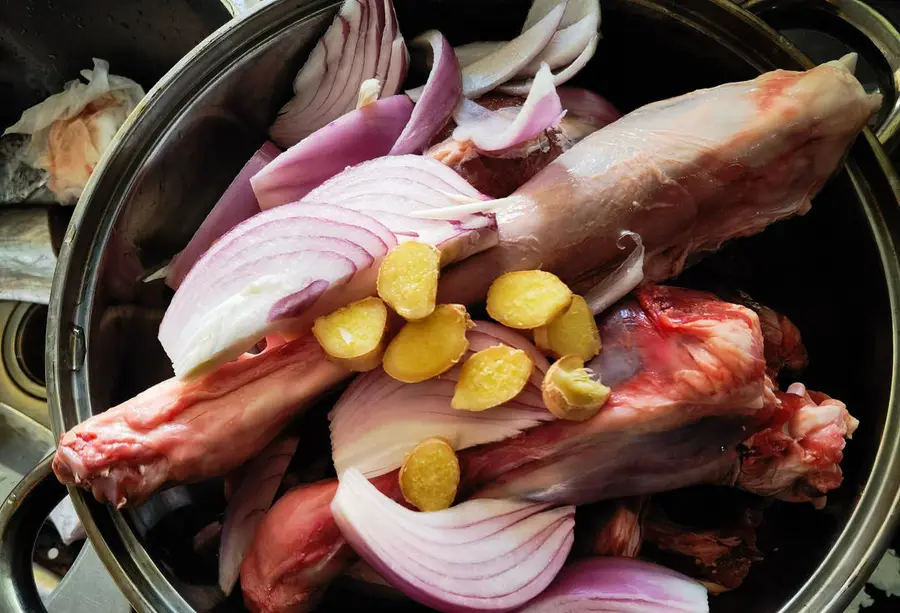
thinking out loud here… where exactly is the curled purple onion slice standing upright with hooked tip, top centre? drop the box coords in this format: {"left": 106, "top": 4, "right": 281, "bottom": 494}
{"left": 391, "top": 30, "right": 462, "bottom": 155}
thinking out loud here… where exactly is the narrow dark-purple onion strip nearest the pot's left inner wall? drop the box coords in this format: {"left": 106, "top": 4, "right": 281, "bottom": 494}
{"left": 167, "top": 142, "right": 281, "bottom": 289}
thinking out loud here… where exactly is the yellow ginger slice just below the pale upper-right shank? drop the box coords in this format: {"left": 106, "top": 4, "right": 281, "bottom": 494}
{"left": 487, "top": 270, "right": 572, "bottom": 330}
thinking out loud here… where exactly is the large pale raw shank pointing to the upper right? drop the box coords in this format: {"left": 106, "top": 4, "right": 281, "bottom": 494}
{"left": 440, "top": 56, "right": 881, "bottom": 303}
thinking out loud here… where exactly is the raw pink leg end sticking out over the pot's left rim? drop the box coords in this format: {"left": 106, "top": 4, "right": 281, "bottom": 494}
{"left": 53, "top": 334, "right": 349, "bottom": 507}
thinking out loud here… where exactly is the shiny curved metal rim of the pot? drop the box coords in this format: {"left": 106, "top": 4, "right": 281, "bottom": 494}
{"left": 47, "top": 0, "right": 900, "bottom": 613}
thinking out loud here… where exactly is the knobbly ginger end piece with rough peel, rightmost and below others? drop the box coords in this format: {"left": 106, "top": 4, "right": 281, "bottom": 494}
{"left": 541, "top": 355, "right": 609, "bottom": 421}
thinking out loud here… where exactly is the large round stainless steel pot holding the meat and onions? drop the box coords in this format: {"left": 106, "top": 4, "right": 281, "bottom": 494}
{"left": 8, "top": 0, "right": 900, "bottom": 613}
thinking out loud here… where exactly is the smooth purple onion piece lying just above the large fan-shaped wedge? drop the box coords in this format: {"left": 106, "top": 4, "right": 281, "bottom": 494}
{"left": 250, "top": 95, "right": 413, "bottom": 209}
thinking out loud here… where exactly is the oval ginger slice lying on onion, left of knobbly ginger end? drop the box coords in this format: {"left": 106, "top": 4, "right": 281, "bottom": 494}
{"left": 450, "top": 345, "right": 534, "bottom": 411}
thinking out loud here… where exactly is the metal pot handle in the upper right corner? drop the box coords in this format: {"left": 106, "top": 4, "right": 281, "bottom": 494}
{"left": 741, "top": 0, "right": 900, "bottom": 152}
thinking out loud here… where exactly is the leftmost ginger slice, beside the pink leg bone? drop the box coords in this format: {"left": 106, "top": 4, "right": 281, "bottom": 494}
{"left": 313, "top": 298, "right": 388, "bottom": 372}
